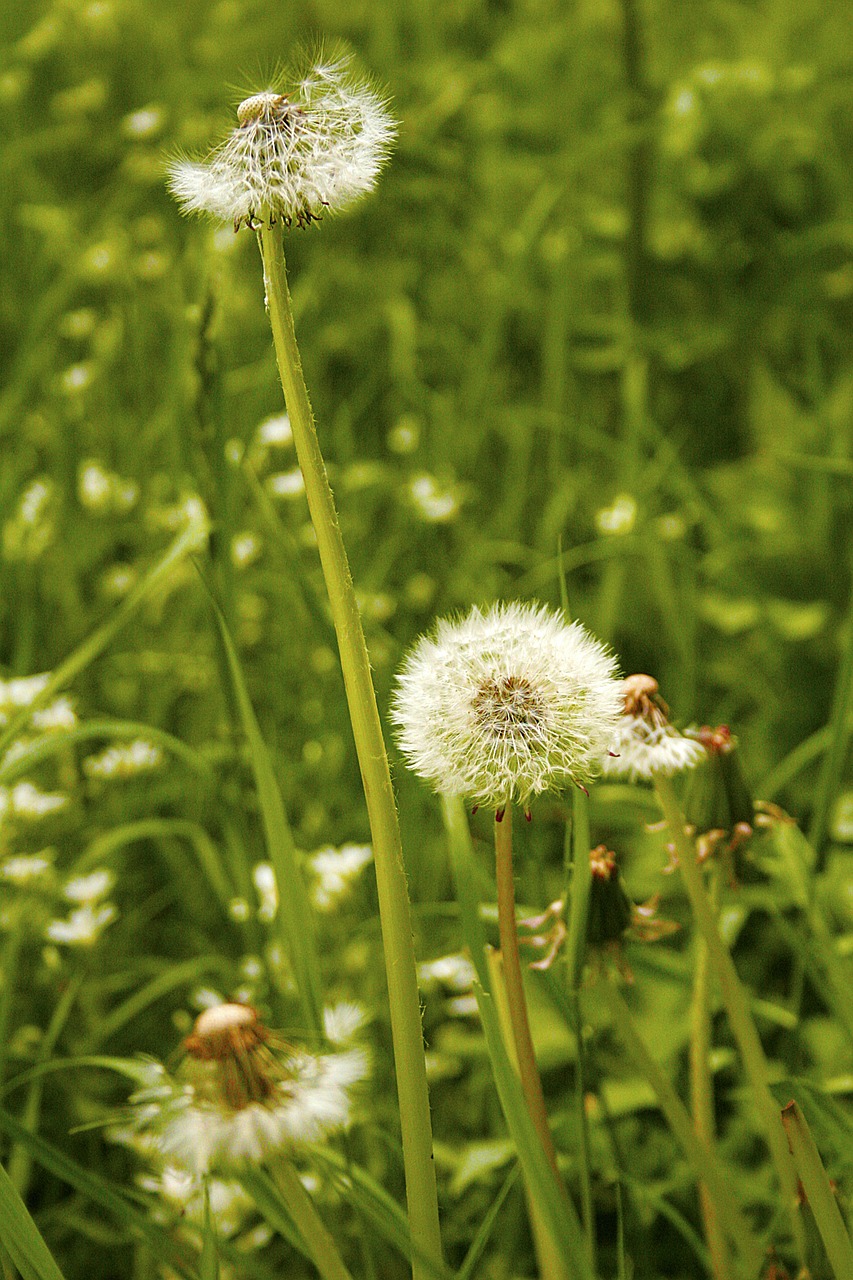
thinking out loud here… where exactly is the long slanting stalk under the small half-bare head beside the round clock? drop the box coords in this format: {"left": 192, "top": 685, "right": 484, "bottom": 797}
{"left": 654, "top": 776, "right": 806, "bottom": 1266}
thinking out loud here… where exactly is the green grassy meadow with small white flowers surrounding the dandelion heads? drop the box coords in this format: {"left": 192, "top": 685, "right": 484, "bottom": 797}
{"left": 0, "top": 0, "right": 853, "bottom": 1280}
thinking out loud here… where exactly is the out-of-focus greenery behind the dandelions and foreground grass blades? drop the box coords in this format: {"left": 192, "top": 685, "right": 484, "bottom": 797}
{"left": 0, "top": 0, "right": 853, "bottom": 1280}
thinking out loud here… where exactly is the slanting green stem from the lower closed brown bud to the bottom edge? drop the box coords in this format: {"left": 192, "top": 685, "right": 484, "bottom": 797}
{"left": 596, "top": 979, "right": 761, "bottom": 1275}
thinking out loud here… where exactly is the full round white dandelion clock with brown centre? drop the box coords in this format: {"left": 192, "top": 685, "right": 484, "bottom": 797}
{"left": 393, "top": 604, "right": 620, "bottom": 809}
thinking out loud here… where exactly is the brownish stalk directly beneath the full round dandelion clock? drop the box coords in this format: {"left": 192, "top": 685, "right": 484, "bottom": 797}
{"left": 494, "top": 804, "right": 562, "bottom": 1185}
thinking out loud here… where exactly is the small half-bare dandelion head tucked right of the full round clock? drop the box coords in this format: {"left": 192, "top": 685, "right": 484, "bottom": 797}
{"left": 605, "top": 676, "right": 704, "bottom": 782}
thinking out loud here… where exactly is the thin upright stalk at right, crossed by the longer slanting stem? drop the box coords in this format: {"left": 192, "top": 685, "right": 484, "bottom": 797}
{"left": 690, "top": 877, "right": 731, "bottom": 1280}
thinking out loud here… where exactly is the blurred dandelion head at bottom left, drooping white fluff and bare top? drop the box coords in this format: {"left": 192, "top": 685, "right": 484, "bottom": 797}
{"left": 124, "top": 1004, "right": 366, "bottom": 1176}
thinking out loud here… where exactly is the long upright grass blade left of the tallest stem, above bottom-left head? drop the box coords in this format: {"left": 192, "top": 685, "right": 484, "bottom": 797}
{"left": 211, "top": 588, "right": 324, "bottom": 1039}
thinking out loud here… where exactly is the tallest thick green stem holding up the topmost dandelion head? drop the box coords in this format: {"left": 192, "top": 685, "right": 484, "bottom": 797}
{"left": 260, "top": 227, "right": 442, "bottom": 1280}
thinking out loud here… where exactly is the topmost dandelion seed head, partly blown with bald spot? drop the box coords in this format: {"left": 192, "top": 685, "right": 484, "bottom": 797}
{"left": 169, "top": 60, "right": 394, "bottom": 230}
